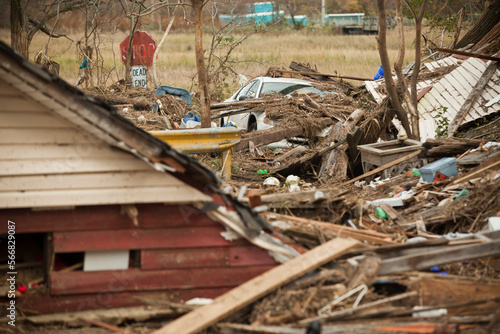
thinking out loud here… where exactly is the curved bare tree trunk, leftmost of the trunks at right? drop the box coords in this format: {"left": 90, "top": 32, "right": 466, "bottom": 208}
{"left": 377, "top": 0, "right": 412, "bottom": 136}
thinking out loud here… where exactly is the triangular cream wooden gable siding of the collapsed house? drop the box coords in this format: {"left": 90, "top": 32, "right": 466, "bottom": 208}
{"left": 0, "top": 80, "right": 209, "bottom": 208}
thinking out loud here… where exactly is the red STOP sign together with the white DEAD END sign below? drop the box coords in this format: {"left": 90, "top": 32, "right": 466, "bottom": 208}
{"left": 120, "top": 31, "right": 156, "bottom": 88}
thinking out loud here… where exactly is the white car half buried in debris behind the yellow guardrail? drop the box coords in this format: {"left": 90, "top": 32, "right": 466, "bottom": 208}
{"left": 220, "top": 77, "right": 336, "bottom": 132}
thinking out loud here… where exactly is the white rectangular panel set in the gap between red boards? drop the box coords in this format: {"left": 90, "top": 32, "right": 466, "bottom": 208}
{"left": 83, "top": 250, "right": 130, "bottom": 271}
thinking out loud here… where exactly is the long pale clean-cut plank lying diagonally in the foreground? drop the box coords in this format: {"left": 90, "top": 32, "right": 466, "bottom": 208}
{"left": 153, "top": 238, "right": 358, "bottom": 334}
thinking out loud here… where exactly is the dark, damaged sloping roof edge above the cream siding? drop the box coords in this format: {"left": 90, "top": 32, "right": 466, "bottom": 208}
{"left": 0, "top": 42, "right": 220, "bottom": 186}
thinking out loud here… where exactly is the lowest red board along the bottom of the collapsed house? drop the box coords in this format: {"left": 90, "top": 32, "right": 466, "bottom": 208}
{"left": 11, "top": 287, "right": 231, "bottom": 314}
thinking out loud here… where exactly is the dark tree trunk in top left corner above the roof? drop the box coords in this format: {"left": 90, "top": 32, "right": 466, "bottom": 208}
{"left": 10, "top": 0, "right": 29, "bottom": 58}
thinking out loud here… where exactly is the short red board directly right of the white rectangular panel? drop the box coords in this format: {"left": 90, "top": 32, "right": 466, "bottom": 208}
{"left": 141, "top": 245, "right": 277, "bottom": 270}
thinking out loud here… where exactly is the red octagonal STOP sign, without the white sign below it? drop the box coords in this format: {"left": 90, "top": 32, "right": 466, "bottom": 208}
{"left": 120, "top": 31, "right": 156, "bottom": 69}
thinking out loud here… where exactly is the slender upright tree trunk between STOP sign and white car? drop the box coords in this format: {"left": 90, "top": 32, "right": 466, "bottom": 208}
{"left": 191, "top": 0, "right": 211, "bottom": 128}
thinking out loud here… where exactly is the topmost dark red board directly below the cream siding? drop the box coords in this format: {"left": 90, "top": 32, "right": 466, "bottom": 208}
{"left": 0, "top": 203, "right": 219, "bottom": 233}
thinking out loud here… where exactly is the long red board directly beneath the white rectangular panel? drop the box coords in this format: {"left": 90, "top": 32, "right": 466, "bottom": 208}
{"left": 51, "top": 265, "right": 274, "bottom": 295}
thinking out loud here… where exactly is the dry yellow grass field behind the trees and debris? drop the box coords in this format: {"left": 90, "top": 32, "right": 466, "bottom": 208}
{"left": 0, "top": 29, "right": 414, "bottom": 98}
